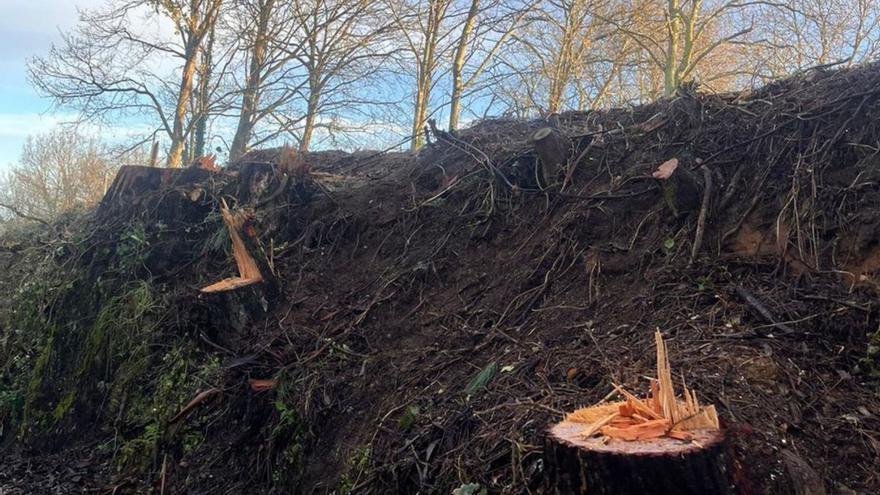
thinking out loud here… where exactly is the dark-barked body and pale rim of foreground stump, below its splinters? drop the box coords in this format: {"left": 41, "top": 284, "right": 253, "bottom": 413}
{"left": 544, "top": 421, "right": 735, "bottom": 495}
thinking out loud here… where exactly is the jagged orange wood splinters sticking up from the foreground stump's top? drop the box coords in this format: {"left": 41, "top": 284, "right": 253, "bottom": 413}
{"left": 565, "top": 331, "right": 720, "bottom": 442}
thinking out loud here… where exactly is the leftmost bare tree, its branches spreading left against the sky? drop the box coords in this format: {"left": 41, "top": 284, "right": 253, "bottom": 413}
{"left": 29, "top": 0, "right": 221, "bottom": 167}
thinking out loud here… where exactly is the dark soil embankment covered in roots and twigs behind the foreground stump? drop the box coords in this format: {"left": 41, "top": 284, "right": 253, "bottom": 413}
{"left": 3, "top": 66, "right": 880, "bottom": 493}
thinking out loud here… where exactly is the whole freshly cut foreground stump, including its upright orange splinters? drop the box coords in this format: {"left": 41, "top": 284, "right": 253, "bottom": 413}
{"left": 544, "top": 331, "right": 735, "bottom": 495}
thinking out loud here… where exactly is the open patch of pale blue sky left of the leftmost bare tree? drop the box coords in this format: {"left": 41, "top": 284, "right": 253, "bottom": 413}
{"left": 0, "top": 0, "right": 102, "bottom": 169}
